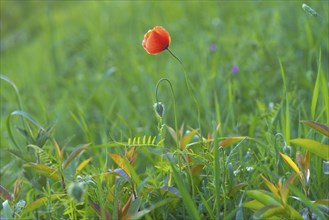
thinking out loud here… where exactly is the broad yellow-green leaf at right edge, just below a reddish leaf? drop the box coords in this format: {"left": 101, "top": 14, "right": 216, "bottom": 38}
{"left": 290, "top": 138, "right": 329, "bottom": 160}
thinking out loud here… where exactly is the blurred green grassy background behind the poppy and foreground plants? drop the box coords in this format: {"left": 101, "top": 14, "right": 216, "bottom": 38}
{"left": 0, "top": 1, "right": 329, "bottom": 157}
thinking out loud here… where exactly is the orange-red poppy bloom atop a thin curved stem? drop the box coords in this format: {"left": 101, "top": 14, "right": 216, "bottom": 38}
{"left": 142, "top": 26, "right": 170, "bottom": 54}
